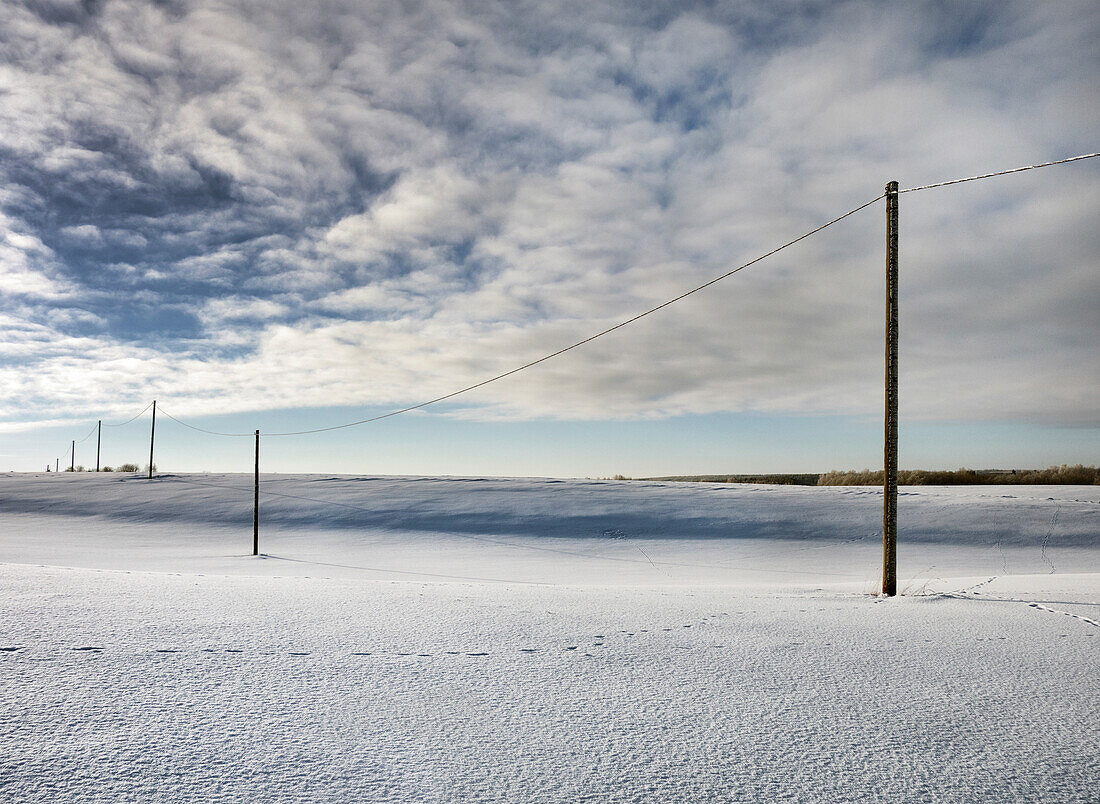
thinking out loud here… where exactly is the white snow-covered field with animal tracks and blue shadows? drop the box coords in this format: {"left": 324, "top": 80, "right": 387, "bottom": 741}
{"left": 0, "top": 474, "right": 1100, "bottom": 802}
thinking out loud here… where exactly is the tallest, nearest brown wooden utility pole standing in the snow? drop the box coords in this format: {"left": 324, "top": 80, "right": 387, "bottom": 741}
{"left": 882, "top": 181, "right": 898, "bottom": 597}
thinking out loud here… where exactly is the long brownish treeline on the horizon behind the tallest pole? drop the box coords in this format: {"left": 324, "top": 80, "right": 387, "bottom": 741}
{"left": 642, "top": 463, "right": 1100, "bottom": 486}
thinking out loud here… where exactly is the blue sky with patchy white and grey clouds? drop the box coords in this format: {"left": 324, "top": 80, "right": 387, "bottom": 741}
{"left": 0, "top": 0, "right": 1100, "bottom": 476}
